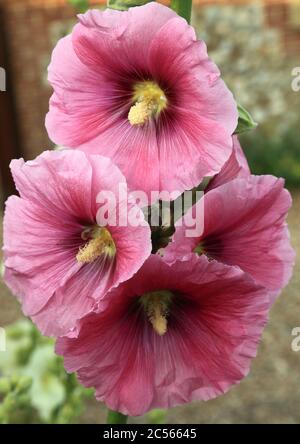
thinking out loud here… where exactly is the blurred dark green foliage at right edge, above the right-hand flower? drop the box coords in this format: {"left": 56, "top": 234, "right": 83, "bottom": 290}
{"left": 240, "top": 128, "right": 300, "bottom": 188}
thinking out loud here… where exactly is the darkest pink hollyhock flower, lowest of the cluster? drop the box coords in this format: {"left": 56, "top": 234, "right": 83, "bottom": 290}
{"left": 56, "top": 255, "right": 268, "bottom": 416}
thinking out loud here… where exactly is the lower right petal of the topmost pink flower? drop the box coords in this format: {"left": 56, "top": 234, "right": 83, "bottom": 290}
{"left": 158, "top": 110, "right": 236, "bottom": 195}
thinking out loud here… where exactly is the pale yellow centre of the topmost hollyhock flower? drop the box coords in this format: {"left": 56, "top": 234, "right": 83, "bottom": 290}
{"left": 128, "top": 80, "right": 168, "bottom": 125}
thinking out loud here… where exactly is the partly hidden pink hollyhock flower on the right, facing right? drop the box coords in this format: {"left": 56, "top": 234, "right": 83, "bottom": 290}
{"left": 164, "top": 176, "right": 295, "bottom": 291}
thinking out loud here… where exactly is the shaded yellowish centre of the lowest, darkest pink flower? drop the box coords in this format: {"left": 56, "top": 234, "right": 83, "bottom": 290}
{"left": 141, "top": 290, "right": 174, "bottom": 336}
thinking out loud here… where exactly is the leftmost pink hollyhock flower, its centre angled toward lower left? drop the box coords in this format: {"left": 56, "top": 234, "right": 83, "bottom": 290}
{"left": 4, "top": 151, "right": 151, "bottom": 336}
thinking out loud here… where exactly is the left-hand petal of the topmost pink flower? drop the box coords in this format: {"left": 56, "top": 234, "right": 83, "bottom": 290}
{"left": 46, "top": 36, "right": 117, "bottom": 147}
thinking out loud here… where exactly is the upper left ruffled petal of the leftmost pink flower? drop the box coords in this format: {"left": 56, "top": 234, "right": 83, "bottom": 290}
{"left": 11, "top": 151, "right": 94, "bottom": 224}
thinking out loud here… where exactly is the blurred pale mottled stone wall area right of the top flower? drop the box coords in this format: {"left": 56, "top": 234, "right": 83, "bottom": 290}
{"left": 193, "top": 3, "right": 300, "bottom": 139}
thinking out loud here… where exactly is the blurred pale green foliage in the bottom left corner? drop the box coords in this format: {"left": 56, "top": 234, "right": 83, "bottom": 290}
{"left": 0, "top": 320, "right": 93, "bottom": 424}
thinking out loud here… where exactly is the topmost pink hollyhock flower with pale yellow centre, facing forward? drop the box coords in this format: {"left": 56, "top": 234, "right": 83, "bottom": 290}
{"left": 46, "top": 2, "right": 238, "bottom": 196}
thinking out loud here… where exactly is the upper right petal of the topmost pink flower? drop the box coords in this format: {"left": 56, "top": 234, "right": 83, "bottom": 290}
{"left": 149, "top": 17, "right": 238, "bottom": 135}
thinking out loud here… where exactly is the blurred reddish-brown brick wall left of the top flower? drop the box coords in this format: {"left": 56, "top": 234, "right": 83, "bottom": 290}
{"left": 0, "top": 0, "right": 82, "bottom": 158}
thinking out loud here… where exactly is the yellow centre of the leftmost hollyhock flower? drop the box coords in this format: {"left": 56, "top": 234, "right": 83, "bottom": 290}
{"left": 76, "top": 225, "right": 116, "bottom": 263}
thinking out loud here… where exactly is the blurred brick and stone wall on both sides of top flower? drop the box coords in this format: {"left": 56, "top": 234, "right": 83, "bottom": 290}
{"left": 0, "top": 0, "right": 300, "bottom": 202}
